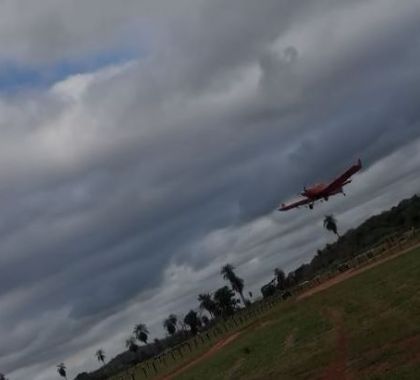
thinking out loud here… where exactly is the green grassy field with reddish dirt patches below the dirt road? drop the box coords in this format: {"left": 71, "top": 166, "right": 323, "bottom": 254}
{"left": 174, "top": 245, "right": 420, "bottom": 380}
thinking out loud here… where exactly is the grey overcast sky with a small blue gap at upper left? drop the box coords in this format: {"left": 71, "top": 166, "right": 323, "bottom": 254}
{"left": 0, "top": 0, "right": 420, "bottom": 380}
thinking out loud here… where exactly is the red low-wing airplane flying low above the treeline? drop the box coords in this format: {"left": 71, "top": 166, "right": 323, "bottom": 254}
{"left": 278, "top": 159, "right": 362, "bottom": 211}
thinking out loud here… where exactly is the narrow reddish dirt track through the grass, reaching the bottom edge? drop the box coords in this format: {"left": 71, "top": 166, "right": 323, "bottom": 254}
{"left": 322, "top": 310, "right": 352, "bottom": 380}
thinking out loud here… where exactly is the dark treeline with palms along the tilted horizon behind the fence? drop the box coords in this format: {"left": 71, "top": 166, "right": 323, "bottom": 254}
{"left": 27, "top": 195, "right": 420, "bottom": 380}
